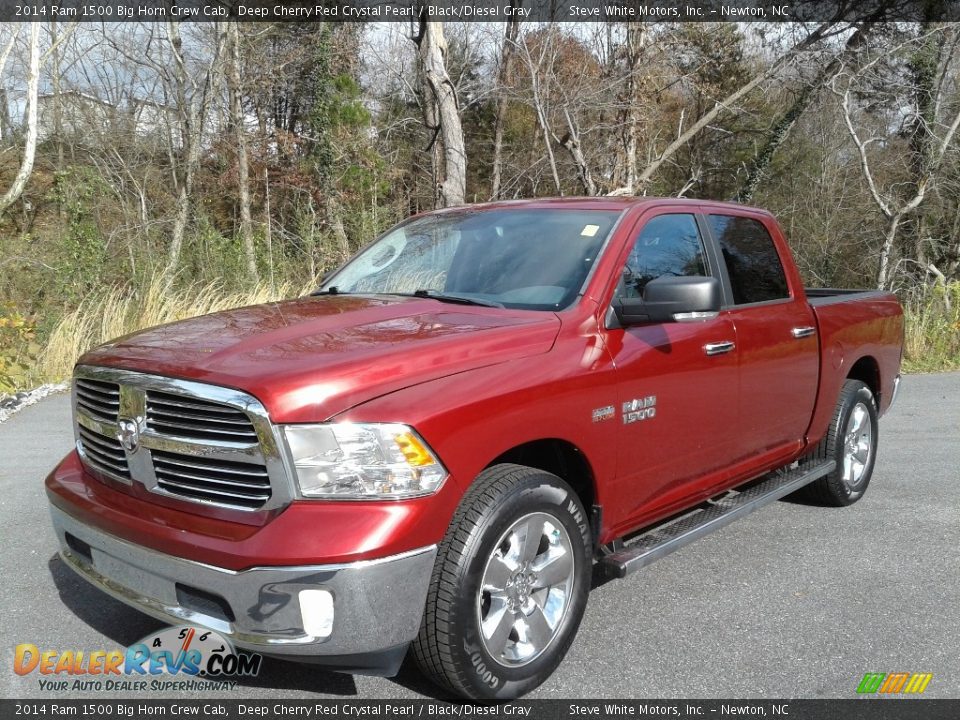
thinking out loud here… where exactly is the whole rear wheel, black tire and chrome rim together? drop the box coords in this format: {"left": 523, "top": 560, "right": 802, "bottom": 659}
{"left": 803, "top": 380, "right": 878, "bottom": 506}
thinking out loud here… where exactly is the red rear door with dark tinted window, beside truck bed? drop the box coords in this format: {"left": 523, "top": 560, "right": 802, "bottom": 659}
{"left": 706, "top": 209, "right": 820, "bottom": 458}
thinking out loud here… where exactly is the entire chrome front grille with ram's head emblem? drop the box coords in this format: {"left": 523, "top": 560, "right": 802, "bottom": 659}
{"left": 73, "top": 366, "right": 293, "bottom": 511}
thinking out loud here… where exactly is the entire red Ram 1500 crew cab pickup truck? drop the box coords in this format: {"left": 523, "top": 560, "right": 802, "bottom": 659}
{"left": 46, "top": 198, "right": 903, "bottom": 698}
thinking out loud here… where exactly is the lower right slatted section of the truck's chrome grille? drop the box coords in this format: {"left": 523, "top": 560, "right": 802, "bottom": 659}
{"left": 152, "top": 450, "right": 271, "bottom": 509}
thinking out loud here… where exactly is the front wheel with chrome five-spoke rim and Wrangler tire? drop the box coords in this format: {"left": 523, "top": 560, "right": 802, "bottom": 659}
{"left": 414, "top": 465, "right": 592, "bottom": 700}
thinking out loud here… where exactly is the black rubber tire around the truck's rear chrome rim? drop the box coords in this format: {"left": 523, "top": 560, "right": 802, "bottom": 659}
{"left": 802, "top": 380, "right": 879, "bottom": 507}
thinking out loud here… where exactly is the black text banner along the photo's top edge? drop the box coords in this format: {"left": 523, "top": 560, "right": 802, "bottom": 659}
{"left": 0, "top": 0, "right": 960, "bottom": 23}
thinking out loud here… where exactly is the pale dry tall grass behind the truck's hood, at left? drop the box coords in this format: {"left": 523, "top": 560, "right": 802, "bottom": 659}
{"left": 32, "top": 274, "right": 316, "bottom": 385}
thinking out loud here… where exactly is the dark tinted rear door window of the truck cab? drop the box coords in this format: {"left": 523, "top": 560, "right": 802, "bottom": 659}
{"left": 709, "top": 215, "right": 790, "bottom": 305}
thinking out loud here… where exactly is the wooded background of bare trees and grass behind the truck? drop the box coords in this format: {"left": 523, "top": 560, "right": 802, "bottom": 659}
{"left": 0, "top": 17, "right": 960, "bottom": 390}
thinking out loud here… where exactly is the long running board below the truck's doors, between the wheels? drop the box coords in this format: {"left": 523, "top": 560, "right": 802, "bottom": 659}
{"left": 600, "top": 460, "right": 837, "bottom": 578}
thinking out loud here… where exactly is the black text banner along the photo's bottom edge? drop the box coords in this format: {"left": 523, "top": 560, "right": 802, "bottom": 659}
{"left": 0, "top": 698, "right": 960, "bottom": 720}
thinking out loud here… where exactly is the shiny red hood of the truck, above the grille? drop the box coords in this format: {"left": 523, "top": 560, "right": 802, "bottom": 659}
{"left": 79, "top": 295, "right": 560, "bottom": 422}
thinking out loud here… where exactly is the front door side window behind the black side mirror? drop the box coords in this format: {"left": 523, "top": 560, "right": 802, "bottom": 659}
{"left": 616, "top": 215, "right": 707, "bottom": 298}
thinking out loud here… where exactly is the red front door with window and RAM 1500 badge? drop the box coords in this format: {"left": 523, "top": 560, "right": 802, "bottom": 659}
{"left": 606, "top": 205, "right": 739, "bottom": 517}
